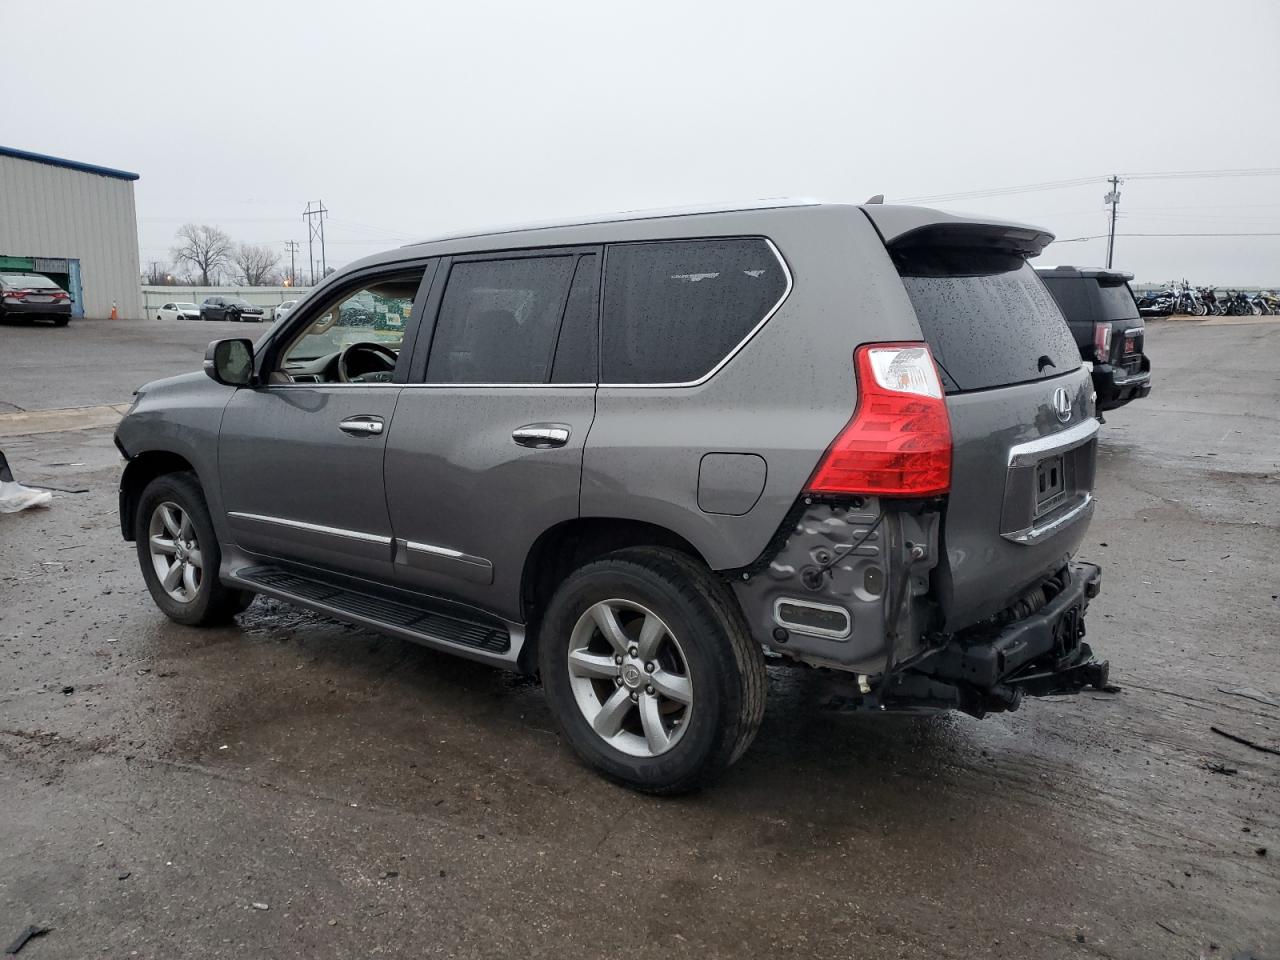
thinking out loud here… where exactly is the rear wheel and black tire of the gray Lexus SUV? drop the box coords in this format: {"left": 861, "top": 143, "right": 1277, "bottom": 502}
{"left": 538, "top": 547, "right": 767, "bottom": 795}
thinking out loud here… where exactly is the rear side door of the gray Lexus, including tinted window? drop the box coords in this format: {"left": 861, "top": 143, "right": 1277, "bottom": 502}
{"left": 387, "top": 247, "right": 602, "bottom": 621}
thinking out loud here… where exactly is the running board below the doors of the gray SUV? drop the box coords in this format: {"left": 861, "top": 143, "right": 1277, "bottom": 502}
{"left": 230, "top": 564, "right": 525, "bottom": 667}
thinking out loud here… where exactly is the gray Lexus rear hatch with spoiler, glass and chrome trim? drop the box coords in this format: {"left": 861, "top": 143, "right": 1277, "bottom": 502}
{"left": 867, "top": 221, "right": 1098, "bottom": 631}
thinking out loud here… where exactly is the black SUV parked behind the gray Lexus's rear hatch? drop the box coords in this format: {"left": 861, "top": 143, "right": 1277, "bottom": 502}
{"left": 1036, "top": 266, "right": 1151, "bottom": 411}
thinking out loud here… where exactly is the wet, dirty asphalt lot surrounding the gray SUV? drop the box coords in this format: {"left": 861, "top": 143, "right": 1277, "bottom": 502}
{"left": 0, "top": 320, "right": 1280, "bottom": 960}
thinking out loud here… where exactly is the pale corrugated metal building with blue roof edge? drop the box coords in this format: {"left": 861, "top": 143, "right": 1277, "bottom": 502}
{"left": 0, "top": 146, "right": 143, "bottom": 319}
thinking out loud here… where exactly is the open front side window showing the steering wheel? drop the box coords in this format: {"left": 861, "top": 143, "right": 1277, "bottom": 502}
{"left": 280, "top": 270, "right": 422, "bottom": 383}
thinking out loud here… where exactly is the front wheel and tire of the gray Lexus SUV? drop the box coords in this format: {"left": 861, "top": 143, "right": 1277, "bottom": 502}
{"left": 133, "top": 472, "right": 253, "bottom": 627}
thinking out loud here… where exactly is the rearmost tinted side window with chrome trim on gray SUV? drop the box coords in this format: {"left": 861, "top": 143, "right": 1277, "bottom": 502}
{"left": 600, "top": 239, "right": 786, "bottom": 383}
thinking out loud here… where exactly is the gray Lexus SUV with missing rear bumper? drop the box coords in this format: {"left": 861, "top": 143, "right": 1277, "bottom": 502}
{"left": 116, "top": 204, "right": 1107, "bottom": 792}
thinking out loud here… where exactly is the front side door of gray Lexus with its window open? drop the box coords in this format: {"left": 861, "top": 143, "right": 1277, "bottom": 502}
{"left": 219, "top": 266, "right": 435, "bottom": 582}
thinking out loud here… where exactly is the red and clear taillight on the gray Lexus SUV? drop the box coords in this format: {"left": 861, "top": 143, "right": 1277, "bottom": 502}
{"left": 805, "top": 343, "right": 951, "bottom": 497}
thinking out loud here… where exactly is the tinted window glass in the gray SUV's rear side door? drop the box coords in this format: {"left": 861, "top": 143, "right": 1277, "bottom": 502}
{"left": 426, "top": 256, "right": 576, "bottom": 383}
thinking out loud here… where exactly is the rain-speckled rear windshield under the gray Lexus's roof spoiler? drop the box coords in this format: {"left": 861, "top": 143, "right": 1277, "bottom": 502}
{"left": 892, "top": 252, "right": 1080, "bottom": 393}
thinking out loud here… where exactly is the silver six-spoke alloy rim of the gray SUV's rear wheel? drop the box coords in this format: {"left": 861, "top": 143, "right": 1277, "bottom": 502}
{"left": 568, "top": 599, "right": 694, "bottom": 756}
